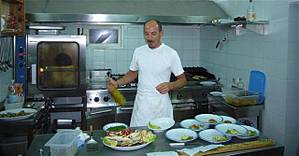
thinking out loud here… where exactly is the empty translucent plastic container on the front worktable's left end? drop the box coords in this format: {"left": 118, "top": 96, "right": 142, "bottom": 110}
{"left": 45, "top": 130, "right": 81, "bottom": 156}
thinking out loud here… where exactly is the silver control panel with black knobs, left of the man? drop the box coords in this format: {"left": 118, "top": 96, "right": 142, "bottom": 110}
{"left": 86, "top": 89, "right": 116, "bottom": 108}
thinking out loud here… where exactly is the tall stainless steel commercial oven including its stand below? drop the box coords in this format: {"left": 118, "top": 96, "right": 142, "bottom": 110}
{"left": 25, "top": 34, "right": 86, "bottom": 131}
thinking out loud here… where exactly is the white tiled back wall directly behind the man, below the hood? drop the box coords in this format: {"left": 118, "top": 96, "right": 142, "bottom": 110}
{"left": 87, "top": 25, "right": 200, "bottom": 74}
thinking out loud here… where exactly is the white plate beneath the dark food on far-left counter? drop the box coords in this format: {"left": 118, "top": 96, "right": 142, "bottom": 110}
{"left": 0, "top": 108, "right": 37, "bottom": 121}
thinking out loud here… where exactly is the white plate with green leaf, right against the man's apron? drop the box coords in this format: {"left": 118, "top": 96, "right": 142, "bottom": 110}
{"left": 147, "top": 118, "right": 175, "bottom": 132}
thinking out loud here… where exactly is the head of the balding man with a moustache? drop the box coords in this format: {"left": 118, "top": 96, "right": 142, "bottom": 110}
{"left": 144, "top": 19, "right": 163, "bottom": 49}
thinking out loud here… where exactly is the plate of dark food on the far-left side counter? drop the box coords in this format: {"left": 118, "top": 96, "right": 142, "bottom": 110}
{"left": 0, "top": 108, "right": 37, "bottom": 121}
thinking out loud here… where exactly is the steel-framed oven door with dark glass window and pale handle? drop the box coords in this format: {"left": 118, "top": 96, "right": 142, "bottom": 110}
{"left": 27, "top": 35, "right": 86, "bottom": 97}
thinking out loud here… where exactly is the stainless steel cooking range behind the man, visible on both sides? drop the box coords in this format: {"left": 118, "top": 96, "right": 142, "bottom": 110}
{"left": 86, "top": 67, "right": 221, "bottom": 129}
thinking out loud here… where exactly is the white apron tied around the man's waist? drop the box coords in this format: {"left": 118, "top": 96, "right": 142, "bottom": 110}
{"left": 130, "top": 91, "right": 173, "bottom": 127}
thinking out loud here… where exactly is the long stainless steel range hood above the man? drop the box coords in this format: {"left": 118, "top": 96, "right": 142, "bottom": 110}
{"left": 25, "top": 0, "right": 228, "bottom": 24}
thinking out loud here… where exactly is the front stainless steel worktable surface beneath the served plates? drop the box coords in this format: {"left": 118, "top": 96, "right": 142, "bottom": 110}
{"left": 26, "top": 124, "right": 284, "bottom": 156}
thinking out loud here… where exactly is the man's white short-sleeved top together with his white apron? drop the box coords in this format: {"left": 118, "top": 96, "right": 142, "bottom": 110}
{"left": 130, "top": 43, "right": 184, "bottom": 127}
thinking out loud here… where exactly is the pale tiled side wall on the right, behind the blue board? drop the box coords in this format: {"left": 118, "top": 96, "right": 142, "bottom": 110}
{"left": 200, "top": 0, "right": 299, "bottom": 155}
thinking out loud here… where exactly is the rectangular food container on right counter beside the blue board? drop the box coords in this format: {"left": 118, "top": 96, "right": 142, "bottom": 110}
{"left": 224, "top": 90, "right": 259, "bottom": 106}
